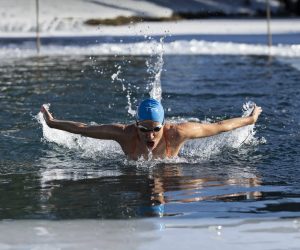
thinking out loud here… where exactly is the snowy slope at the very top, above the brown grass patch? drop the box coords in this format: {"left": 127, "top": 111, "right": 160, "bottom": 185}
{"left": 0, "top": 0, "right": 283, "bottom": 32}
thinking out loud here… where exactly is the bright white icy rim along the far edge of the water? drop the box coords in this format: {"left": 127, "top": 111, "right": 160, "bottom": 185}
{"left": 0, "top": 40, "right": 300, "bottom": 60}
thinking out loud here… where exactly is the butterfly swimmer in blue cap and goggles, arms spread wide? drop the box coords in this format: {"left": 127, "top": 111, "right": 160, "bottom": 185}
{"left": 41, "top": 98, "right": 262, "bottom": 160}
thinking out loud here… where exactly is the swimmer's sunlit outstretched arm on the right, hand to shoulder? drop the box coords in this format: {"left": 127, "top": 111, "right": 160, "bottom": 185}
{"left": 178, "top": 106, "right": 262, "bottom": 141}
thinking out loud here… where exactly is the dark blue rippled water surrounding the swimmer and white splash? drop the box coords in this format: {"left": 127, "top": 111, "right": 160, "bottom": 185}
{"left": 0, "top": 52, "right": 300, "bottom": 219}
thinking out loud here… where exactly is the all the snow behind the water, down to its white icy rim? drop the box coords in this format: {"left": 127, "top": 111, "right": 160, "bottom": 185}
{"left": 0, "top": 0, "right": 300, "bottom": 58}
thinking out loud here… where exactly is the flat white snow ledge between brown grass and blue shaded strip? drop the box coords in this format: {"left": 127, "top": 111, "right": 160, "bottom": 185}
{"left": 0, "top": 19, "right": 300, "bottom": 37}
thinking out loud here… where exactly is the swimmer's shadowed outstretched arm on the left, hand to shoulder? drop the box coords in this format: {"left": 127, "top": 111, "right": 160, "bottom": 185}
{"left": 41, "top": 106, "right": 125, "bottom": 141}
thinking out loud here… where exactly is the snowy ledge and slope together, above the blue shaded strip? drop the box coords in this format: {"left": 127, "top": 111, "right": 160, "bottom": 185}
{"left": 0, "top": 0, "right": 300, "bottom": 37}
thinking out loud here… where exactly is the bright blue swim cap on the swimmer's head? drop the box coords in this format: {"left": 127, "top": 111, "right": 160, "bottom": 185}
{"left": 137, "top": 98, "right": 165, "bottom": 124}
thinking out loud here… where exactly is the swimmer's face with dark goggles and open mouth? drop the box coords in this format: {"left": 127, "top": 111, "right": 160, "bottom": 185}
{"left": 137, "top": 120, "right": 163, "bottom": 150}
